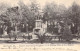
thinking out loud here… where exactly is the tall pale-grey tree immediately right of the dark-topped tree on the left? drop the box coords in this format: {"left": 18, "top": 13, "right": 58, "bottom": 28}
{"left": 18, "top": 1, "right": 31, "bottom": 24}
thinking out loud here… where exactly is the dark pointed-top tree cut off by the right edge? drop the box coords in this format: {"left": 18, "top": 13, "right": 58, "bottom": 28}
{"left": 71, "top": 2, "right": 80, "bottom": 25}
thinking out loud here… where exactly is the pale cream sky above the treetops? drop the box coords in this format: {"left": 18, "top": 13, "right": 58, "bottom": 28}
{"left": 0, "top": 0, "right": 80, "bottom": 7}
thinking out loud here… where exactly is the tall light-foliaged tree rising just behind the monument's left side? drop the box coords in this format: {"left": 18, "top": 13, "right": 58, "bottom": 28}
{"left": 29, "top": 0, "right": 41, "bottom": 30}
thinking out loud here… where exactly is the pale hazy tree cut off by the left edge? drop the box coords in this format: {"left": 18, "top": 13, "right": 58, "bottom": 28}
{"left": 0, "top": 3, "right": 10, "bottom": 24}
